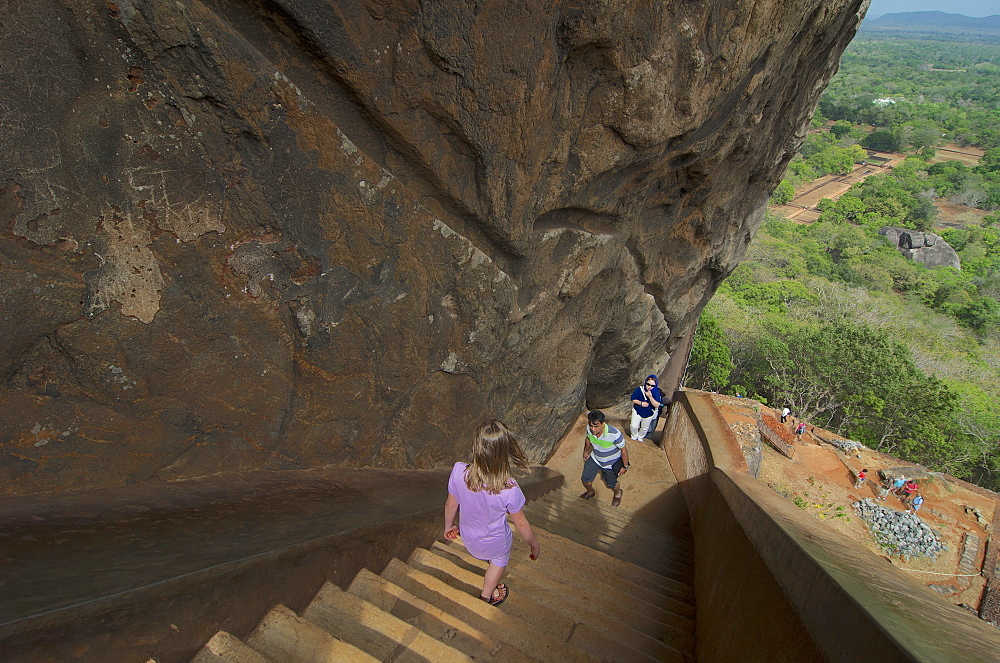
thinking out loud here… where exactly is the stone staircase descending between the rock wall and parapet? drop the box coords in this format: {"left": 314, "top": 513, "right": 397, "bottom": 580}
{"left": 194, "top": 488, "right": 695, "bottom": 663}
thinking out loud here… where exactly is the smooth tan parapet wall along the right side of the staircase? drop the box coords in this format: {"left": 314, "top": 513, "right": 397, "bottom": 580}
{"left": 663, "top": 392, "right": 1000, "bottom": 662}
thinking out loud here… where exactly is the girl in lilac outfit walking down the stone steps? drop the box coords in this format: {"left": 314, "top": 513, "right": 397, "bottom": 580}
{"left": 444, "top": 419, "right": 539, "bottom": 605}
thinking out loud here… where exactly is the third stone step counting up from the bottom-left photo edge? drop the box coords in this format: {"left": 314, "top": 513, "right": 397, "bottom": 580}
{"left": 302, "top": 583, "right": 472, "bottom": 663}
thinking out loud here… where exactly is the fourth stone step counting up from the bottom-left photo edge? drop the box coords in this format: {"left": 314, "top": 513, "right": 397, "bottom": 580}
{"left": 347, "top": 569, "right": 541, "bottom": 663}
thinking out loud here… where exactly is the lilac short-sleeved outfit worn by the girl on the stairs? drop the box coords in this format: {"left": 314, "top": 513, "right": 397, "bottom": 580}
{"left": 448, "top": 463, "right": 526, "bottom": 566}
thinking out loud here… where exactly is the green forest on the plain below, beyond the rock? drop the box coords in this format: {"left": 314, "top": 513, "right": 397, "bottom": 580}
{"left": 685, "top": 35, "right": 1000, "bottom": 490}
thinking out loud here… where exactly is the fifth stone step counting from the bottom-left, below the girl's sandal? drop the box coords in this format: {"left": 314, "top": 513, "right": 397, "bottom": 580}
{"left": 381, "top": 559, "right": 598, "bottom": 662}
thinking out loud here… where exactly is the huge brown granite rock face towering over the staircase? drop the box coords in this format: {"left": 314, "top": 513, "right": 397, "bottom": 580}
{"left": 0, "top": 0, "right": 867, "bottom": 493}
